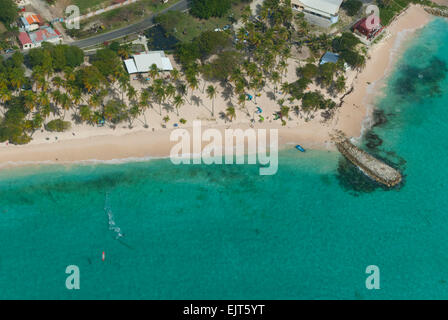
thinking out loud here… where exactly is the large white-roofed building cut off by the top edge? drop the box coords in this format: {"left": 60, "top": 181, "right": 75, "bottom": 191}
{"left": 291, "top": 0, "right": 342, "bottom": 23}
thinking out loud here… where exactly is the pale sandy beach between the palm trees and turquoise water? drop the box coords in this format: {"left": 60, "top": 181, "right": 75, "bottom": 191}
{"left": 0, "top": 5, "right": 431, "bottom": 168}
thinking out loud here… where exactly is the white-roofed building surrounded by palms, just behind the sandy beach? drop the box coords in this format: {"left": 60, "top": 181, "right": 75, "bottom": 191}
{"left": 124, "top": 51, "right": 173, "bottom": 74}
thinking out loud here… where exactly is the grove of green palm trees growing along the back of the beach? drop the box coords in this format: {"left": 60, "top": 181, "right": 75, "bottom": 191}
{"left": 0, "top": 0, "right": 365, "bottom": 144}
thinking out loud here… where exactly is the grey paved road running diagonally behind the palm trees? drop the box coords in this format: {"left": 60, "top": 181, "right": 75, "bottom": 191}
{"left": 70, "top": 0, "right": 188, "bottom": 49}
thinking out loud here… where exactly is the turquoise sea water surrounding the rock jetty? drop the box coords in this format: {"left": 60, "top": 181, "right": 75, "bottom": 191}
{"left": 0, "top": 19, "right": 448, "bottom": 299}
